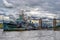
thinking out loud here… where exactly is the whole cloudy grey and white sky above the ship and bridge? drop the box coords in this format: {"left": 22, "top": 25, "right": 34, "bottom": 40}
{"left": 0, "top": 0, "right": 60, "bottom": 18}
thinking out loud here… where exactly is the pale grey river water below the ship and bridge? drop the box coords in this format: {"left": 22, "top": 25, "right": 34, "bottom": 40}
{"left": 0, "top": 29, "right": 60, "bottom": 40}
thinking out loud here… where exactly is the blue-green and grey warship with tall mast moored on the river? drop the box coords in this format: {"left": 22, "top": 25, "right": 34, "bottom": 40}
{"left": 3, "top": 10, "right": 37, "bottom": 31}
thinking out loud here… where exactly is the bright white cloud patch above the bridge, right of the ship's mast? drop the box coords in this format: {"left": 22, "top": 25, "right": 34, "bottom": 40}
{"left": 27, "top": 8, "right": 56, "bottom": 19}
